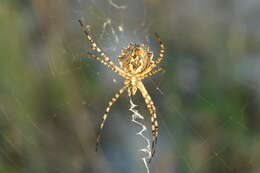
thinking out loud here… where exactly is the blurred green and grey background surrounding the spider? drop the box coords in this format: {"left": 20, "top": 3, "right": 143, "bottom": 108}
{"left": 0, "top": 0, "right": 260, "bottom": 173}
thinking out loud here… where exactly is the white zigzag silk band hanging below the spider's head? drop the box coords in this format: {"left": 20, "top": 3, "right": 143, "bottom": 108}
{"left": 129, "top": 97, "right": 152, "bottom": 173}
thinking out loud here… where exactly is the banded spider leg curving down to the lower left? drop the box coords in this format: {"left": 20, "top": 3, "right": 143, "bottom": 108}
{"left": 96, "top": 85, "right": 128, "bottom": 151}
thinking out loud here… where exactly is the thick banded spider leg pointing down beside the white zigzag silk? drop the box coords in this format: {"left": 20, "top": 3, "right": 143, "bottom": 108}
{"left": 138, "top": 82, "right": 158, "bottom": 163}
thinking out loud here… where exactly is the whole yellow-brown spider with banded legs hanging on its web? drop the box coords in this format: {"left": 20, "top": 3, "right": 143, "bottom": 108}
{"left": 78, "top": 20, "right": 164, "bottom": 162}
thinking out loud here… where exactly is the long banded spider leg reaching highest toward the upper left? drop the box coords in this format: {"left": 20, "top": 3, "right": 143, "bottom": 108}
{"left": 78, "top": 20, "right": 119, "bottom": 71}
